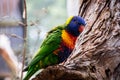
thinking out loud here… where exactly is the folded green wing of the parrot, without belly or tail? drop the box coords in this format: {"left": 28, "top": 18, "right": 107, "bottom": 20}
{"left": 29, "top": 26, "right": 64, "bottom": 66}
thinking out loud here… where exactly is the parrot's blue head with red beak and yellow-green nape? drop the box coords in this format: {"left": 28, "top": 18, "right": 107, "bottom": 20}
{"left": 66, "top": 16, "right": 86, "bottom": 36}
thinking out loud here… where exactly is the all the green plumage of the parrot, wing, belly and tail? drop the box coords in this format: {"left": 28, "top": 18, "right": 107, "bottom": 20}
{"left": 23, "top": 25, "right": 66, "bottom": 80}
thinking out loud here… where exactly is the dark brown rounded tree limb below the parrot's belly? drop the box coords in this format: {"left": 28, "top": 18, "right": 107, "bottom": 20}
{"left": 33, "top": 65, "right": 93, "bottom": 80}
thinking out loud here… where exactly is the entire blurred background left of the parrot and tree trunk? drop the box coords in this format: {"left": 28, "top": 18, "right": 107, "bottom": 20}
{"left": 0, "top": 0, "right": 68, "bottom": 80}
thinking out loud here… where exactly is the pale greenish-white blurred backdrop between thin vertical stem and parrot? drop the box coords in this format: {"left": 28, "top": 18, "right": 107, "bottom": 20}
{"left": 26, "top": 0, "right": 67, "bottom": 61}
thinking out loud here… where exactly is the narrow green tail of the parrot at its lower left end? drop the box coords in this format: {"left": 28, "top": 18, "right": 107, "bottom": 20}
{"left": 23, "top": 67, "right": 40, "bottom": 80}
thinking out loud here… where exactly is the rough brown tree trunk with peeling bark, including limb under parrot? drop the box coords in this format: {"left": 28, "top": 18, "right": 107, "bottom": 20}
{"left": 33, "top": 0, "right": 120, "bottom": 80}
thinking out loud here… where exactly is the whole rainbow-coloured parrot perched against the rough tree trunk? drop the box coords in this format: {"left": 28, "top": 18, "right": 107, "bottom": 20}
{"left": 23, "top": 16, "right": 86, "bottom": 80}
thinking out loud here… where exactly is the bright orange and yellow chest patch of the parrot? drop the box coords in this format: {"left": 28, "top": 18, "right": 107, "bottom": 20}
{"left": 62, "top": 30, "right": 77, "bottom": 49}
